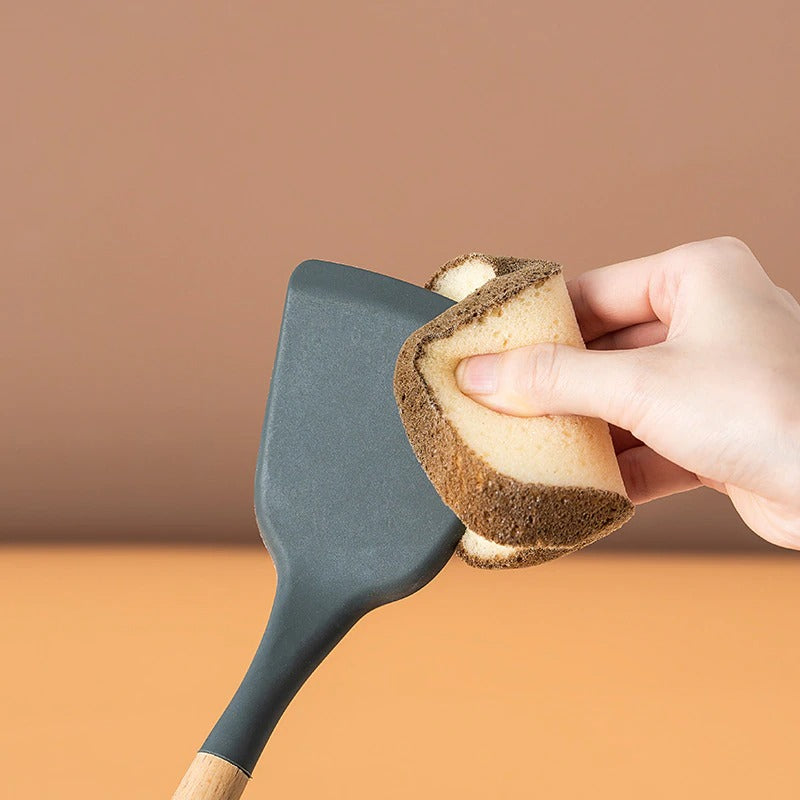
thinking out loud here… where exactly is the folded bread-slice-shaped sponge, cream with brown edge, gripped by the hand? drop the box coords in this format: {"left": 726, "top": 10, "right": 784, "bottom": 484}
{"left": 394, "top": 253, "right": 633, "bottom": 567}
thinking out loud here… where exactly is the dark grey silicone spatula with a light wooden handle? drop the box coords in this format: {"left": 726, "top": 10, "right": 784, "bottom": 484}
{"left": 173, "top": 261, "right": 463, "bottom": 800}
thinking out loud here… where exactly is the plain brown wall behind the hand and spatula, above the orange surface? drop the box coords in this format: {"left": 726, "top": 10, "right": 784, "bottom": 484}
{"left": 0, "top": 0, "right": 800, "bottom": 547}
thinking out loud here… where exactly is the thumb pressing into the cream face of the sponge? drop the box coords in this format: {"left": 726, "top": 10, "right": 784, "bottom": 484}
{"left": 456, "top": 343, "right": 654, "bottom": 430}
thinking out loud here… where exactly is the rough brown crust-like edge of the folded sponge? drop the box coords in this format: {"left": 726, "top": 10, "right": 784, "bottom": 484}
{"left": 394, "top": 255, "right": 633, "bottom": 552}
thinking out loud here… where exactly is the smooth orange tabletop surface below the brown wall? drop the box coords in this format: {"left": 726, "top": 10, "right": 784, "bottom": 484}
{"left": 0, "top": 546, "right": 800, "bottom": 800}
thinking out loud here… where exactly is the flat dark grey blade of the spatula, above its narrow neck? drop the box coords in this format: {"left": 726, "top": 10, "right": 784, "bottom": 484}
{"left": 256, "top": 261, "right": 466, "bottom": 608}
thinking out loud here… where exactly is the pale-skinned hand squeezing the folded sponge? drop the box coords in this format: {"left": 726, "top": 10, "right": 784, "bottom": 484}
{"left": 456, "top": 237, "right": 800, "bottom": 550}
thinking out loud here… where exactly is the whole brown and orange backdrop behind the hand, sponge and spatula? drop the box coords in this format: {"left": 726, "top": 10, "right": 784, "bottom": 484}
{"left": 0, "top": 0, "right": 800, "bottom": 799}
